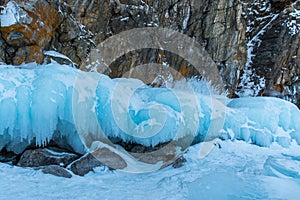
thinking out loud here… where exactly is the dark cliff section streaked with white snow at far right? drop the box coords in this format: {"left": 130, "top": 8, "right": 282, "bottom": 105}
{"left": 237, "top": 0, "right": 300, "bottom": 105}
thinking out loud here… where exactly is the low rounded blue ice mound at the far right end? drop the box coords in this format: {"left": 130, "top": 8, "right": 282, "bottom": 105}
{"left": 224, "top": 97, "right": 300, "bottom": 147}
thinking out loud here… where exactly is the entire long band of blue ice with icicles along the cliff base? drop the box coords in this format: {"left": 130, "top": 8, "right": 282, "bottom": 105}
{"left": 0, "top": 63, "right": 300, "bottom": 153}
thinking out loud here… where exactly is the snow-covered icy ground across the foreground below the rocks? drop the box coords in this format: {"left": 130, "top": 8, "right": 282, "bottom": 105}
{"left": 0, "top": 141, "right": 300, "bottom": 200}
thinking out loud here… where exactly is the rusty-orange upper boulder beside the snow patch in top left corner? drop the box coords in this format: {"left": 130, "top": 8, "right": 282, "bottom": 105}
{"left": 0, "top": 0, "right": 62, "bottom": 48}
